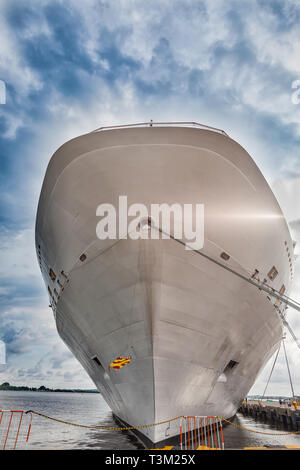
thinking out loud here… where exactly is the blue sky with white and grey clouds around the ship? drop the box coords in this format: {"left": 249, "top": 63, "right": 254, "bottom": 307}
{"left": 0, "top": 0, "right": 300, "bottom": 395}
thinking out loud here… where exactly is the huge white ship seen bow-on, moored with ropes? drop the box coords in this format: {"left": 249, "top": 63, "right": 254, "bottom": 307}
{"left": 36, "top": 121, "right": 294, "bottom": 444}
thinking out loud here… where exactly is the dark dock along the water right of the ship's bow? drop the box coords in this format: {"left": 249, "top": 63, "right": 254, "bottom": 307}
{"left": 239, "top": 400, "right": 300, "bottom": 431}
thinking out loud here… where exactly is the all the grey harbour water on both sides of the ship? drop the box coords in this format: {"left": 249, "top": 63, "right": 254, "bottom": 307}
{"left": 0, "top": 391, "right": 300, "bottom": 450}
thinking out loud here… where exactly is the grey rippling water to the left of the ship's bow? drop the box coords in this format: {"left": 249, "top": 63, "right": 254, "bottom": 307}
{"left": 0, "top": 391, "right": 144, "bottom": 450}
